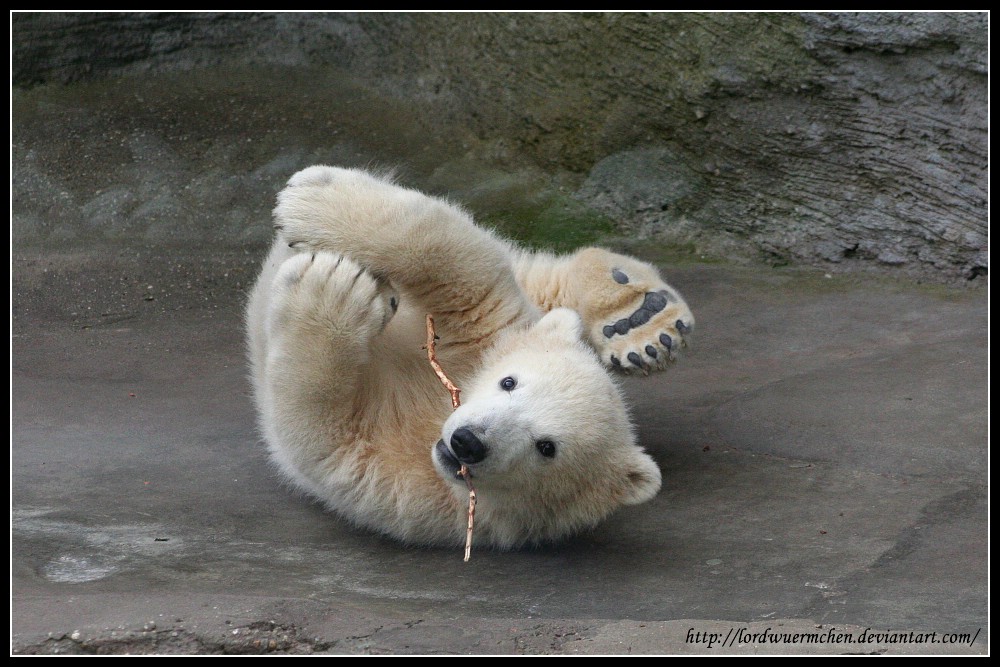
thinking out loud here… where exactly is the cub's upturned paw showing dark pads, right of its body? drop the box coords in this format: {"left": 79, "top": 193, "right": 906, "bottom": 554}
{"left": 572, "top": 249, "right": 694, "bottom": 373}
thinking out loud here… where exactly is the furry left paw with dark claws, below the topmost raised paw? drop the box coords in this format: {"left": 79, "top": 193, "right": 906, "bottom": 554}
{"left": 268, "top": 252, "right": 399, "bottom": 341}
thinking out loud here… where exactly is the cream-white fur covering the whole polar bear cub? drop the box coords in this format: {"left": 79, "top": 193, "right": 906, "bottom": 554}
{"left": 246, "top": 166, "right": 693, "bottom": 548}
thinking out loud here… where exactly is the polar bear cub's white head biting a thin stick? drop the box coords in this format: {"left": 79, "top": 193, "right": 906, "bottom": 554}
{"left": 433, "top": 308, "right": 660, "bottom": 547}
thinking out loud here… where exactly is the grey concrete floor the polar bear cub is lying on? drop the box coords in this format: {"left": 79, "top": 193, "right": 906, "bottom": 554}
{"left": 11, "top": 70, "right": 989, "bottom": 655}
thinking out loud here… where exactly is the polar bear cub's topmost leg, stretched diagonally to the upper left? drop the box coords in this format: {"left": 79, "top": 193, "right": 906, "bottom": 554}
{"left": 274, "top": 166, "right": 538, "bottom": 366}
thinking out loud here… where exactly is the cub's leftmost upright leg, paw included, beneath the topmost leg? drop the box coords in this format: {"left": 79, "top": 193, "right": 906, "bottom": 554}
{"left": 253, "top": 252, "right": 397, "bottom": 480}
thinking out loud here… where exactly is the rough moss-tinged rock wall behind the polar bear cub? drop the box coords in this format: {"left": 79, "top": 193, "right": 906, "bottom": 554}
{"left": 12, "top": 12, "right": 988, "bottom": 282}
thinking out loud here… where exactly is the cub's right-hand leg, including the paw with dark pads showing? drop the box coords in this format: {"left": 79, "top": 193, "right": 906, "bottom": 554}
{"left": 515, "top": 248, "right": 694, "bottom": 373}
